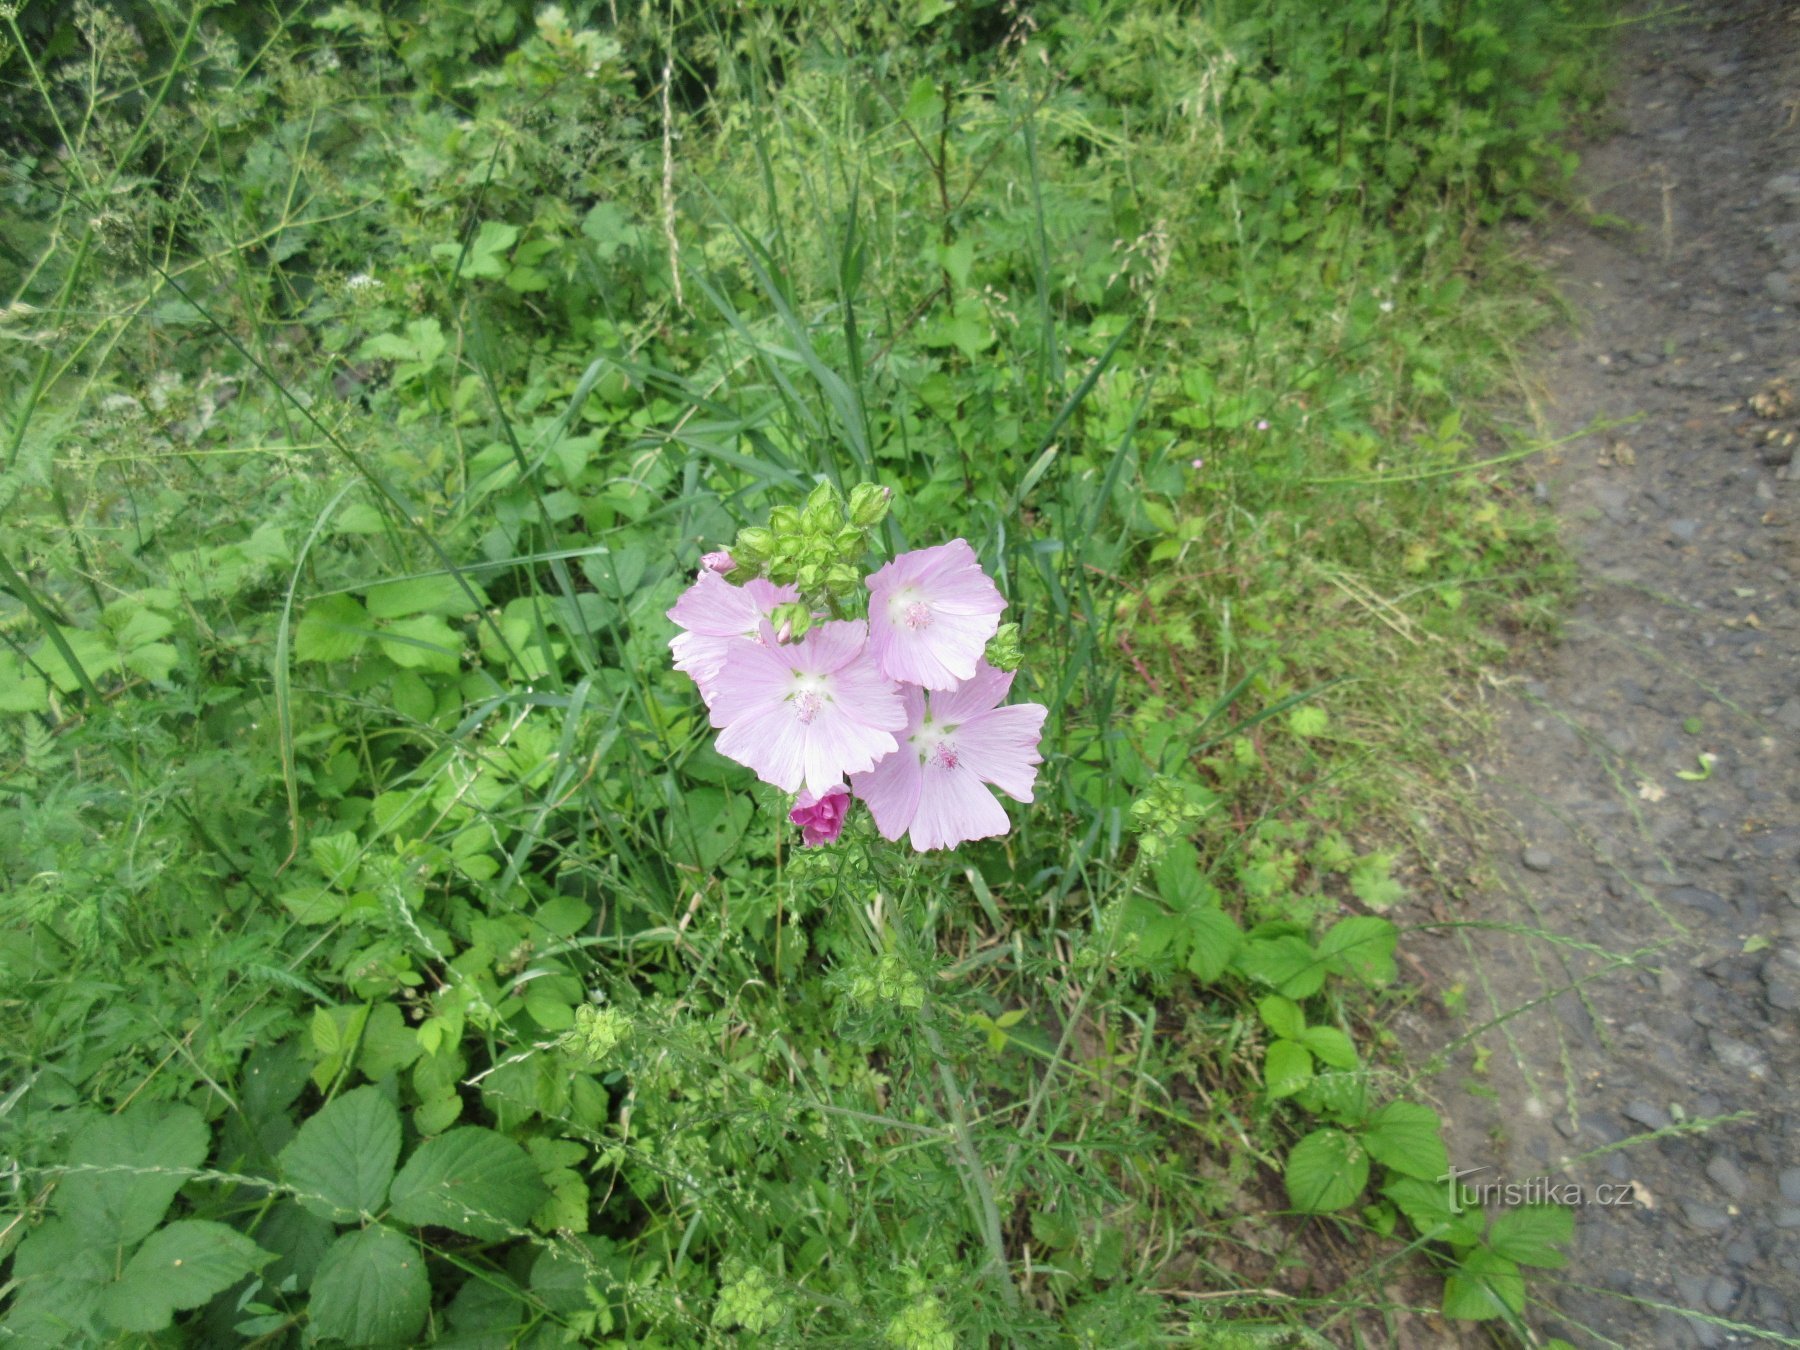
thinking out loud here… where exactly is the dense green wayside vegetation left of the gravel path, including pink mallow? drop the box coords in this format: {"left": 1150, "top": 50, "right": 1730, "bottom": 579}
{"left": 0, "top": 0, "right": 1598, "bottom": 1348}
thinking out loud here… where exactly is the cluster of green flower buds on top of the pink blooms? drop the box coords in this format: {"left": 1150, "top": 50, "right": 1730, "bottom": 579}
{"left": 731, "top": 482, "right": 893, "bottom": 612}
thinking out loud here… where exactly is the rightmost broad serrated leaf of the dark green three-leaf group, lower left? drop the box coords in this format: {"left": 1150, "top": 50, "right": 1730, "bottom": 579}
{"left": 392, "top": 1125, "right": 549, "bottom": 1238}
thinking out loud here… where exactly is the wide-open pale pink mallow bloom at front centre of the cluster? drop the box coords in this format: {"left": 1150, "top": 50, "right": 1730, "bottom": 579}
{"left": 711, "top": 621, "right": 905, "bottom": 796}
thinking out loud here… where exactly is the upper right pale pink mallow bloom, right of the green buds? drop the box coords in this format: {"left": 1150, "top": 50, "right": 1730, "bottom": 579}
{"left": 868, "top": 538, "right": 1006, "bottom": 689}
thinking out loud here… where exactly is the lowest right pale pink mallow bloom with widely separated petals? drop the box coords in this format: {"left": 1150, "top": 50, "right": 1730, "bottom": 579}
{"left": 850, "top": 661, "right": 1048, "bottom": 851}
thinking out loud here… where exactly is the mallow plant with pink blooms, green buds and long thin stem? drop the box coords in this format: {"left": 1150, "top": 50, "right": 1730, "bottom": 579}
{"left": 668, "top": 484, "right": 1048, "bottom": 1314}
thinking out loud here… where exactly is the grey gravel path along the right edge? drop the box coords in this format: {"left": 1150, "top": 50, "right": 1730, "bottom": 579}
{"left": 1413, "top": 0, "right": 1800, "bottom": 1348}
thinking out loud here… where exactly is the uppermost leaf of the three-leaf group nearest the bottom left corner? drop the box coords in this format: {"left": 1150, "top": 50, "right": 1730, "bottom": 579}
{"left": 56, "top": 1102, "right": 212, "bottom": 1246}
